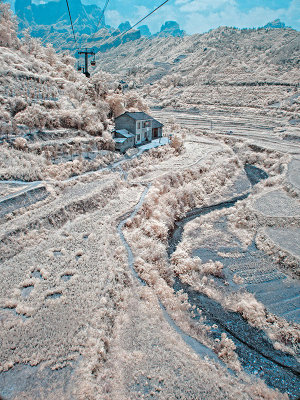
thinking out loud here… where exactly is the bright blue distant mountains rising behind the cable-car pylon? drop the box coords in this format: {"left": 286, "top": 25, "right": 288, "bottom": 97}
{"left": 15, "top": 0, "right": 185, "bottom": 52}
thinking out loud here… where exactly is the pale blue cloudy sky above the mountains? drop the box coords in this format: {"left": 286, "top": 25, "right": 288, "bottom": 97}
{"left": 10, "top": 0, "right": 300, "bottom": 34}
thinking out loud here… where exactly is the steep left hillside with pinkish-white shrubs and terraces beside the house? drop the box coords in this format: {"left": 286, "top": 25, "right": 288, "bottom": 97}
{"left": 0, "top": 3, "right": 146, "bottom": 180}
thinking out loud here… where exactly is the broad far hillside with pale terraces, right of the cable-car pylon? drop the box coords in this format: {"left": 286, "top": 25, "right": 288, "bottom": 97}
{"left": 97, "top": 27, "right": 300, "bottom": 117}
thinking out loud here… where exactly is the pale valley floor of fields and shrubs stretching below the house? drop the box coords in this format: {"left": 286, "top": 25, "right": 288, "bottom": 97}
{"left": 0, "top": 109, "right": 300, "bottom": 400}
